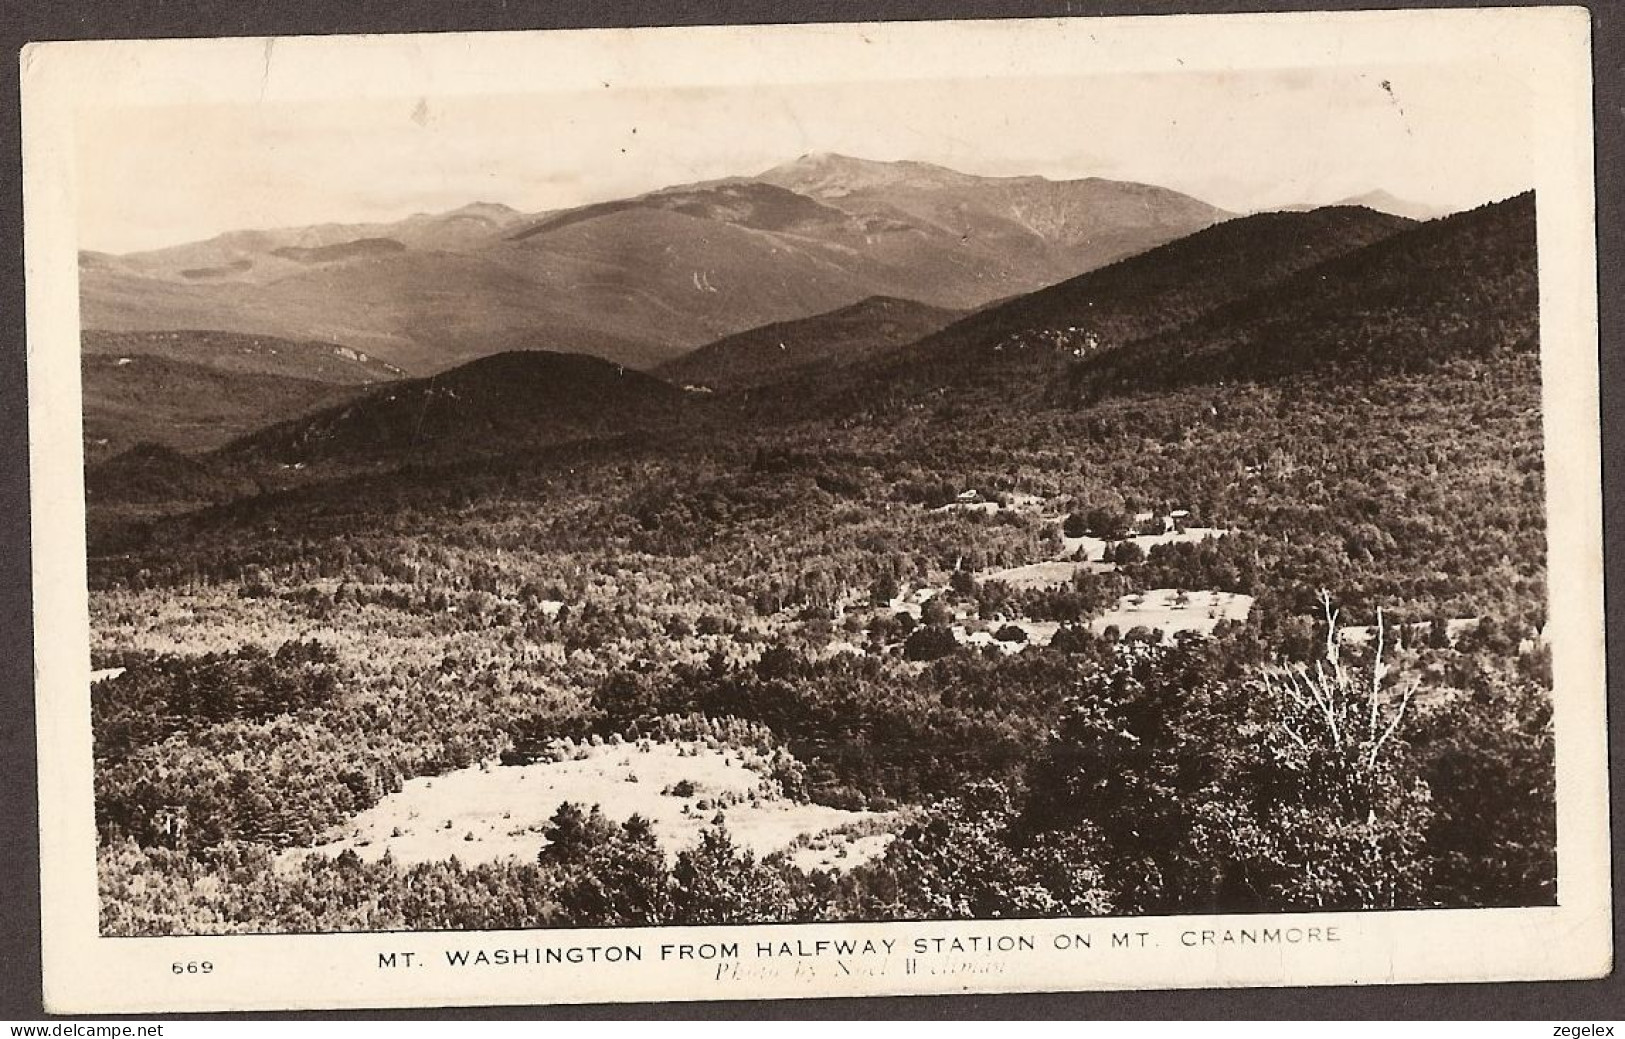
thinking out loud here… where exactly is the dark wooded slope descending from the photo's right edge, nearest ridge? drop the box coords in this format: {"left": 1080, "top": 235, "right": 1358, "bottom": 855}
{"left": 1077, "top": 193, "right": 1539, "bottom": 393}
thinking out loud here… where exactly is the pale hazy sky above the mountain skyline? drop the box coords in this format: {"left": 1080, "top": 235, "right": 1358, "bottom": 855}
{"left": 78, "top": 65, "right": 1532, "bottom": 252}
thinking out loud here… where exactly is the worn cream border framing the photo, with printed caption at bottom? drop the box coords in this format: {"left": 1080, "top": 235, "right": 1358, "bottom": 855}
{"left": 21, "top": 8, "right": 1612, "bottom": 1013}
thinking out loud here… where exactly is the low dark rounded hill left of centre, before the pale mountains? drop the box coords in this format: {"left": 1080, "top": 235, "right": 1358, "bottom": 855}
{"left": 221, "top": 351, "right": 684, "bottom": 467}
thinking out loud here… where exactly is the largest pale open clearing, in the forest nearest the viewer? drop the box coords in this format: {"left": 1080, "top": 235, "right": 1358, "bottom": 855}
{"left": 299, "top": 741, "right": 889, "bottom": 868}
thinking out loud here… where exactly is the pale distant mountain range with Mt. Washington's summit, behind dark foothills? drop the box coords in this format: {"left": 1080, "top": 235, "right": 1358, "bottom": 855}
{"left": 80, "top": 154, "right": 1230, "bottom": 376}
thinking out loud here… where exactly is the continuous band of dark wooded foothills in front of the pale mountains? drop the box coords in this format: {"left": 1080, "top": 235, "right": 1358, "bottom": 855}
{"left": 85, "top": 186, "right": 1537, "bottom": 486}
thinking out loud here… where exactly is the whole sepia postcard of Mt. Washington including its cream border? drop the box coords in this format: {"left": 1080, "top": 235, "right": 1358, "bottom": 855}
{"left": 21, "top": 8, "right": 1612, "bottom": 1013}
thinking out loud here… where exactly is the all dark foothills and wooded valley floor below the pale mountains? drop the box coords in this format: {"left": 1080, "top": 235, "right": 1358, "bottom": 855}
{"left": 91, "top": 198, "right": 1557, "bottom": 933}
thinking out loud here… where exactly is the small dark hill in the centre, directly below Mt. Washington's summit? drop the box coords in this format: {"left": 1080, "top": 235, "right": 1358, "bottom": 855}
{"left": 655, "top": 296, "right": 964, "bottom": 390}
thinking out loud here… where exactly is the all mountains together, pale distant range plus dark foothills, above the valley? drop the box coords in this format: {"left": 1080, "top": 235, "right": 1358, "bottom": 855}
{"left": 81, "top": 147, "right": 1534, "bottom": 499}
